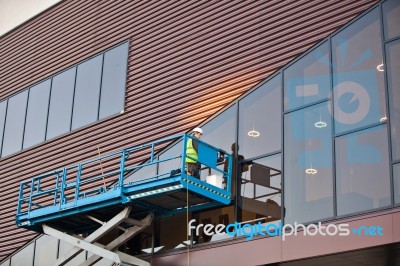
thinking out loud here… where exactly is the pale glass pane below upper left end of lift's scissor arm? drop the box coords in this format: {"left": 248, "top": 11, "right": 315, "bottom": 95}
{"left": 34, "top": 235, "right": 58, "bottom": 266}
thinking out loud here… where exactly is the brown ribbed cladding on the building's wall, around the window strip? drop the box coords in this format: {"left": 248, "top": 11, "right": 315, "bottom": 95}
{"left": 0, "top": 0, "right": 376, "bottom": 261}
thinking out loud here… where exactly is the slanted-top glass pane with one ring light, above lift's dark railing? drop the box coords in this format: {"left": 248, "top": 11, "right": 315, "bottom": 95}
{"left": 238, "top": 75, "right": 282, "bottom": 159}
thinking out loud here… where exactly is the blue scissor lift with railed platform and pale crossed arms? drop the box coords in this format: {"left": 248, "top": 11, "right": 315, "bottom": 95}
{"left": 16, "top": 134, "right": 232, "bottom": 265}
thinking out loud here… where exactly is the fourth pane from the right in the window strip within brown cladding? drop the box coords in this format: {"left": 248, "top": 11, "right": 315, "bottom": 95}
{"left": 23, "top": 80, "right": 51, "bottom": 149}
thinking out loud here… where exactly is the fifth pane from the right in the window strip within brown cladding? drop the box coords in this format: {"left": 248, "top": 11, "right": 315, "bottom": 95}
{"left": 1, "top": 90, "right": 28, "bottom": 157}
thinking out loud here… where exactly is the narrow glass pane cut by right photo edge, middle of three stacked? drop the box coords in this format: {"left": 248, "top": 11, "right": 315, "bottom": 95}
{"left": 386, "top": 41, "right": 400, "bottom": 160}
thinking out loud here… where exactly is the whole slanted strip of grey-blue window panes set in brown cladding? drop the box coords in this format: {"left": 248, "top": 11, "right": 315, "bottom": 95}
{"left": 0, "top": 42, "right": 129, "bottom": 157}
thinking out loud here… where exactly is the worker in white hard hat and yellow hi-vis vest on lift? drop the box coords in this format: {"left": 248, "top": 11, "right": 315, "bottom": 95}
{"left": 185, "top": 127, "right": 203, "bottom": 179}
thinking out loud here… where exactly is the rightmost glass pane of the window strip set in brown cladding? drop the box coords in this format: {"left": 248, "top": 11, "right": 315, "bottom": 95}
{"left": 99, "top": 43, "right": 128, "bottom": 119}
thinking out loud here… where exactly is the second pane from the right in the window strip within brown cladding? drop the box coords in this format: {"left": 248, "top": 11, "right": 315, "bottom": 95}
{"left": 72, "top": 55, "right": 103, "bottom": 129}
